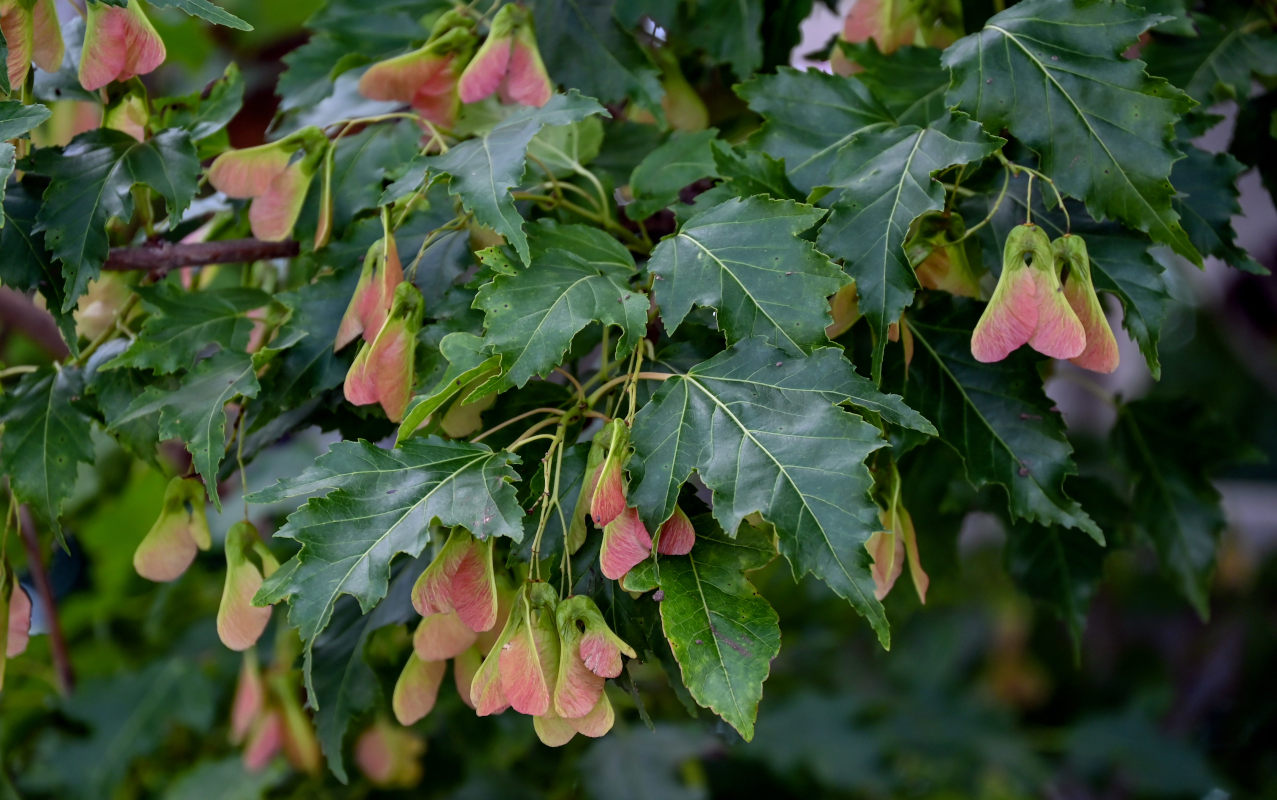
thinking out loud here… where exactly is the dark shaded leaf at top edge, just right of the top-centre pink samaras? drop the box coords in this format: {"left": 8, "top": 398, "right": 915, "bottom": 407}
{"left": 533, "top": 0, "right": 664, "bottom": 112}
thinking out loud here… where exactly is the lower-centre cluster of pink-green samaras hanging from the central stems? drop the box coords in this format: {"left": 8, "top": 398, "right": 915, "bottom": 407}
{"left": 383, "top": 419, "right": 696, "bottom": 746}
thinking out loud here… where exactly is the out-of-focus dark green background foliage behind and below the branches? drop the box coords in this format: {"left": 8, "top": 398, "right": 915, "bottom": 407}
{"left": 0, "top": 0, "right": 1277, "bottom": 800}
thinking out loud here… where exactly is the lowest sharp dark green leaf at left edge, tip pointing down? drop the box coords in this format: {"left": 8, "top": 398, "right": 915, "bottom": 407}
{"left": 0, "top": 367, "right": 93, "bottom": 535}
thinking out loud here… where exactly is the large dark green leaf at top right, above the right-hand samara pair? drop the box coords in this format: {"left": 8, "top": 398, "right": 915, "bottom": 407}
{"left": 941, "top": 0, "right": 1202, "bottom": 263}
